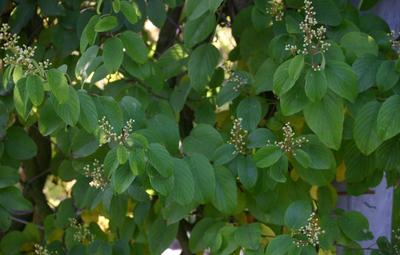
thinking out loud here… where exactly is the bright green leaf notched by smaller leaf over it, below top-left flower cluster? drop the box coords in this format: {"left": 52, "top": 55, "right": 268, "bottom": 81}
{"left": 50, "top": 87, "right": 80, "bottom": 126}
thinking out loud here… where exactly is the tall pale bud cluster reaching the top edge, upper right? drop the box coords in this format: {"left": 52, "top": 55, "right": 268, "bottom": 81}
{"left": 285, "top": 0, "right": 331, "bottom": 62}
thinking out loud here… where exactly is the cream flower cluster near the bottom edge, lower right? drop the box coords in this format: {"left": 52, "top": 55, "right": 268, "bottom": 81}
{"left": 292, "top": 212, "right": 325, "bottom": 247}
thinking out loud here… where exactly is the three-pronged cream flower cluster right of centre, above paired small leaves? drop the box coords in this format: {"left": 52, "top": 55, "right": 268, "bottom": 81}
{"left": 267, "top": 122, "right": 308, "bottom": 156}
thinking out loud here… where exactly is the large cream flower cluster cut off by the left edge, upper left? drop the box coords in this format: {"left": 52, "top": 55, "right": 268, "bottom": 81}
{"left": 0, "top": 24, "right": 50, "bottom": 74}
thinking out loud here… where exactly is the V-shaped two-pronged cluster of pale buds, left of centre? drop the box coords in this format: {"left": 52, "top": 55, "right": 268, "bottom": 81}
{"left": 99, "top": 116, "right": 135, "bottom": 145}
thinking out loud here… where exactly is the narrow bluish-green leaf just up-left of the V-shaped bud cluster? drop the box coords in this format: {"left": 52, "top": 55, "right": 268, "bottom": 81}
{"left": 78, "top": 90, "right": 99, "bottom": 133}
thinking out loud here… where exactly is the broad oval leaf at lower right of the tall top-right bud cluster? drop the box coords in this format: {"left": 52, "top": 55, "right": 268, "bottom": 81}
{"left": 325, "top": 61, "right": 358, "bottom": 102}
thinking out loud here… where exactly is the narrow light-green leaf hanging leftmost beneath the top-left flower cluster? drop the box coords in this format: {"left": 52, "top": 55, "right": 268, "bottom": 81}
{"left": 13, "top": 78, "right": 32, "bottom": 120}
